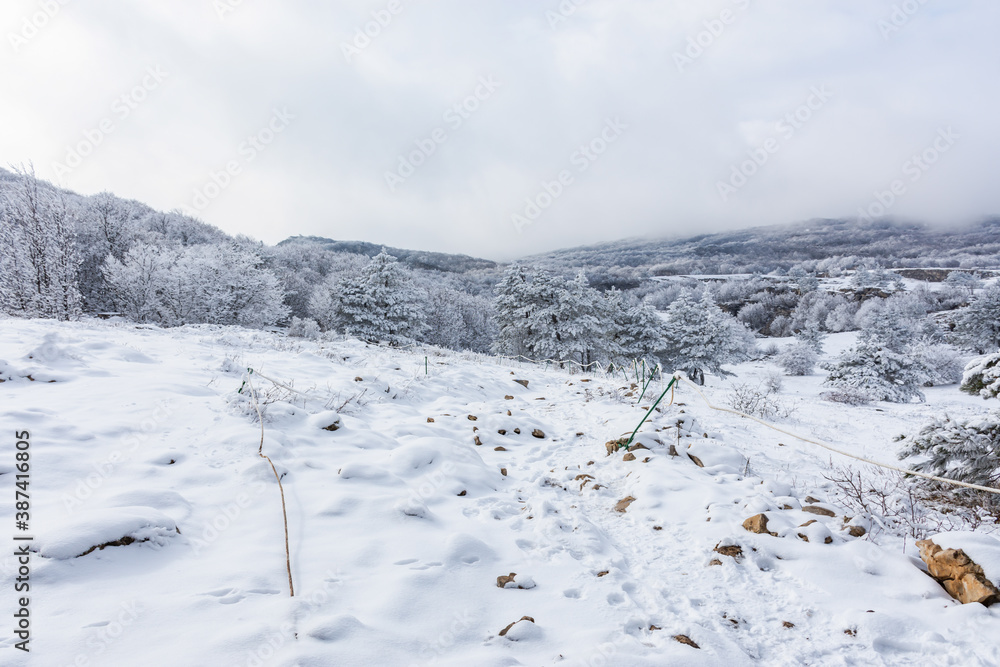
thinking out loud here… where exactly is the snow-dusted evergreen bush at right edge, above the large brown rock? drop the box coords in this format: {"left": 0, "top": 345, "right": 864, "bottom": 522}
{"left": 899, "top": 412, "right": 1000, "bottom": 507}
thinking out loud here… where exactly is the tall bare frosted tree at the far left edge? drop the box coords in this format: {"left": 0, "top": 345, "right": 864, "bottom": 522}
{"left": 0, "top": 167, "right": 82, "bottom": 320}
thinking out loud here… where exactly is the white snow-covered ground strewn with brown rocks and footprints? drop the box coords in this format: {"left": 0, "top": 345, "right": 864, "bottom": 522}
{"left": 0, "top": 319, "right": 1000, "bottom": 667}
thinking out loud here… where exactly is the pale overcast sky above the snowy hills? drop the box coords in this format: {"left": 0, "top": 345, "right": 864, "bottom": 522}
{"left": 0, "top": 0, "right": 1000, "bottom": 259}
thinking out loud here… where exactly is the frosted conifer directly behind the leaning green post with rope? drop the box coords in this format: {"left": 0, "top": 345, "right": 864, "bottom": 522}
{"left": 659, "top": 291, "right": 754, "bottom": 378}
